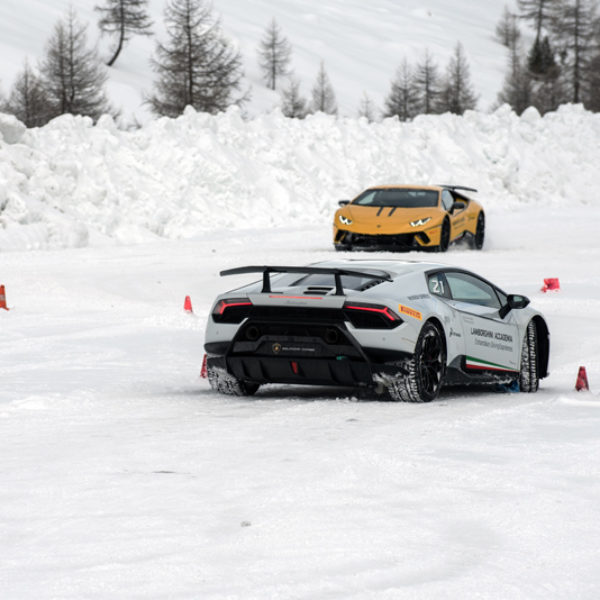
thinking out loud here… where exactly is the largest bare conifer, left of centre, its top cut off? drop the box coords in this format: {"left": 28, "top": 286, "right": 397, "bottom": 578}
{"left": 148, "top": 0, "right": 243, "bottom": 117}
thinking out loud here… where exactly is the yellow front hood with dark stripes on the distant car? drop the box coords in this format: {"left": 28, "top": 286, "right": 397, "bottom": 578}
{"left": 339, "top": 204, "right": 442, "bottom": 234}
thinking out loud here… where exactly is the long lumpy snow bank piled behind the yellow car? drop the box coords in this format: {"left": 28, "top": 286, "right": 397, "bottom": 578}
{"left": 0, "top": 106, "right": 600, "bottom": 250}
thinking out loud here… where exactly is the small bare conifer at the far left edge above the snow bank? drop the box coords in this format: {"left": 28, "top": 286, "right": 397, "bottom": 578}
{"left": 5, "top": 61, "right": 52, "bottom": 127}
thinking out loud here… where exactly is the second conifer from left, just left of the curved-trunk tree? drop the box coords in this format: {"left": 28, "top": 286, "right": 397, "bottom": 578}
{"left": 40, "top": 9, "right": 111, "bottom": 120}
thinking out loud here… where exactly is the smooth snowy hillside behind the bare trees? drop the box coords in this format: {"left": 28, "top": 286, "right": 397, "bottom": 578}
{"left": 0, "top": 0, "right": 513, "bottom": 122}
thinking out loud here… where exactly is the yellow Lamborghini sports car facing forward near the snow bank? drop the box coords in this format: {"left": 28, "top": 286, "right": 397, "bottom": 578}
{"left": 333, "top": 185, "right": 485, "bottom": 252}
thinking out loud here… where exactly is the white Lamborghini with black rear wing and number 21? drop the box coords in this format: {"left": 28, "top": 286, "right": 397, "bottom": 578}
{"left": 204, "top": 260, "right": 550, "bottom": 402}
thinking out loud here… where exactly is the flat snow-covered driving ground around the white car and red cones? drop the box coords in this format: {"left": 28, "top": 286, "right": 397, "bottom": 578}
{"left": 0, "top": 209, "right": 600, "bottom": 600}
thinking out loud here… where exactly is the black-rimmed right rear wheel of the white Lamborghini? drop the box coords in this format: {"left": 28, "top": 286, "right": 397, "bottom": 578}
{"left": 388, "top": 321, "right": 446, "bottom": 402}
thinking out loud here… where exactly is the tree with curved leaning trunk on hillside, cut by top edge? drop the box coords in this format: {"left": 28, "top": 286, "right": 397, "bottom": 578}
{"left": 95, "top": 0, "right": 152, "bottom": 67}
